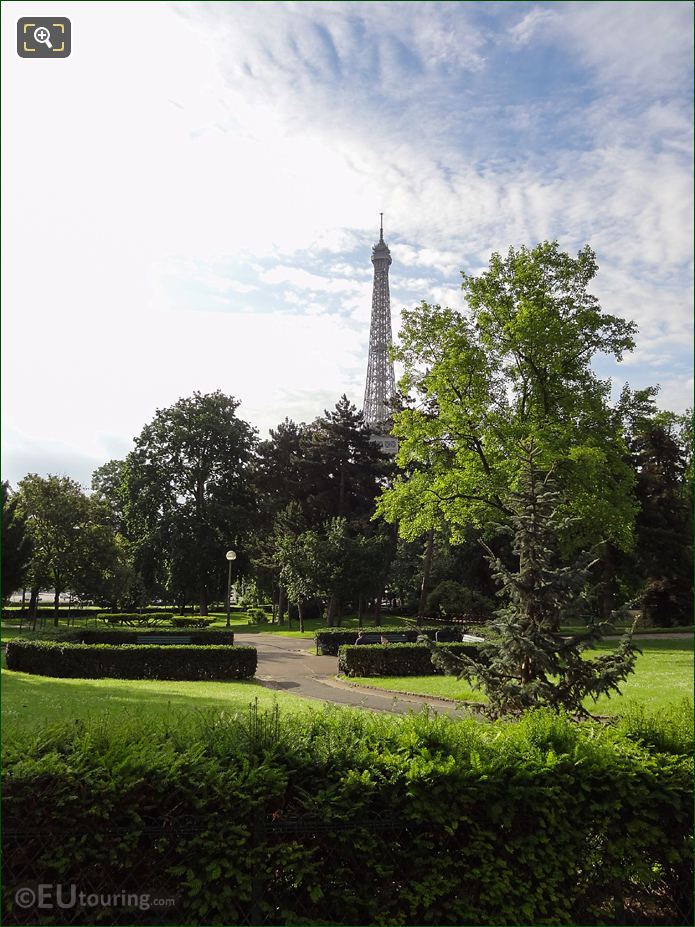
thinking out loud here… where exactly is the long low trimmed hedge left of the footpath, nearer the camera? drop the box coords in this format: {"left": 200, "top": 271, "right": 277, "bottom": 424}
{"left": 7, "top": 638, "right": 257, "bottom": 680}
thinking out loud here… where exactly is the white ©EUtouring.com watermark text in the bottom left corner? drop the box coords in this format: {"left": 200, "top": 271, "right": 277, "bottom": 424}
{"left": 14, "top": 882, "right": 177, "bottom": 911}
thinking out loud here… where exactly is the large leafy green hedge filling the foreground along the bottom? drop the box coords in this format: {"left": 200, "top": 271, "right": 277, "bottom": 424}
{"left": 3, "top": 710, "right": 693, "bottom": 927}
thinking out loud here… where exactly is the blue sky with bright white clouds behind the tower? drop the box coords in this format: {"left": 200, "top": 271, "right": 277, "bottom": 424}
{"left": 2, "top": 2, "right": 693, "bottom": 483}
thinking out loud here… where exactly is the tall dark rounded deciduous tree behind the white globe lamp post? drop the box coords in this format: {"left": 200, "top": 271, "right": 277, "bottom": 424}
{"left": 126, "top": 390, "right": 256, "bottom": 615}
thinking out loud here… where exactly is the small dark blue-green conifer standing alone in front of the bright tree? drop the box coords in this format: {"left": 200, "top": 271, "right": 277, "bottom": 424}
{"left": 433, "top": 446, "right": 638, "bottom": 717}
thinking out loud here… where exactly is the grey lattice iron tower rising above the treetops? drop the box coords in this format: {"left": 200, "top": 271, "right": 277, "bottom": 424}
{"left": 364, "top": 212, "right": 396, "bottom": 434}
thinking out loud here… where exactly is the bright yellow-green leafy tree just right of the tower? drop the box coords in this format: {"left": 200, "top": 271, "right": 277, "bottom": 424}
{"left": 379, "top": 242, "right": 635, "bottom": 549}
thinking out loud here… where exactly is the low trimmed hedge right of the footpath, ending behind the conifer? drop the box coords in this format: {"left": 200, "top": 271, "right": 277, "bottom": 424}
{"left": 338, "top": 643, "right": 485, "bottom": 676}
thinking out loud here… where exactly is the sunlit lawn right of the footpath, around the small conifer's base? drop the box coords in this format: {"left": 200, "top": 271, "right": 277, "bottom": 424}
{"left": 350, "top": 638, "right": 693, "bottom": 715}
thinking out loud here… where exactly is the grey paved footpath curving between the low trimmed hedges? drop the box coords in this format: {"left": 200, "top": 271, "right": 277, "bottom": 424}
{"left": 234, "top": 632, "right": 470, "bottom": 717}
